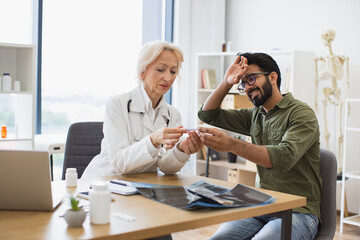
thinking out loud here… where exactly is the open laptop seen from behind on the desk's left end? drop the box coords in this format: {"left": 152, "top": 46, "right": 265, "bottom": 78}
{"left": 0, "top": 150, "right": 66, "bottom": 211}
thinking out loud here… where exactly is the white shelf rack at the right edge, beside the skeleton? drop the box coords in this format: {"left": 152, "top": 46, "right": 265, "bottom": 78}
{"left": 340, "top": 98, "right": 360, "bottom": 233}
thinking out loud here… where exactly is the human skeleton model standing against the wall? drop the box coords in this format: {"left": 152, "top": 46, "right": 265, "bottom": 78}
{"left": 315, "top": 29, "right": 349, "bottom": 173}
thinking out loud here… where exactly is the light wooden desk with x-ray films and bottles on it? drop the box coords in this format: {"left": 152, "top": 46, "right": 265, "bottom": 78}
{"left": 0, "top": 173, "right": 306, "bottom": 240}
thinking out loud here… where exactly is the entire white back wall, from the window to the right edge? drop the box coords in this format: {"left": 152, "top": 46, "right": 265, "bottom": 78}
{"left": 174, "top": 0, "right": 360, "bottom": 212}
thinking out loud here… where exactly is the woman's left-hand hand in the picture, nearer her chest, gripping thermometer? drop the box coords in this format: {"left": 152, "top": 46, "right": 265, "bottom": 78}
{"left": 150, "top": 126, "right": 187, "bottom": 149}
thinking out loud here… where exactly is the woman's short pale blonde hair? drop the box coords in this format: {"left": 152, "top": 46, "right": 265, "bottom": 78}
{"left": 136, "top": 40, "right": 184, "bottom": 81}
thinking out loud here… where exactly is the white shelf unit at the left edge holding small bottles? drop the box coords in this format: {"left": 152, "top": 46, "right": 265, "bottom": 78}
{"left": 0, "top": 43, "right": 36, "bottom": 149}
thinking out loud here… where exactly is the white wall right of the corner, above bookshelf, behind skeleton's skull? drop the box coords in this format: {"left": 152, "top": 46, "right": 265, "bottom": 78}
{"left": 226, "top": 0, "right": 360, "bottom": 97}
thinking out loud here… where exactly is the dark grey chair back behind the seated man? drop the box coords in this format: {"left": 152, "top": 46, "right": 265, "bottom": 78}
{"left": 315, "top": 149, "right": 337, "bottom": 240}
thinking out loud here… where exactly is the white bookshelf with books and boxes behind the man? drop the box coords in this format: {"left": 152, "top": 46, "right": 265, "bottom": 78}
{"left": 193, "top": 51, "right": 315, "bottom": 180}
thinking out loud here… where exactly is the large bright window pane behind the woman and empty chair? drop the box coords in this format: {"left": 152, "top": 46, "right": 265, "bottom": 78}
{"left": 41, "top": 0, "right": 143, "bottom": 134}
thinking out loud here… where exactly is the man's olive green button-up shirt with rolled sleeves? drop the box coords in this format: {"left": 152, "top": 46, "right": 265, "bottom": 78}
{"left": 198, "top": 93, "right": 321, "bottom": 219}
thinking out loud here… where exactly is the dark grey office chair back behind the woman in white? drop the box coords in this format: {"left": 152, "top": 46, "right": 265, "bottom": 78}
{"left": 62, "top": 122, "right": 104, "bottom": 180}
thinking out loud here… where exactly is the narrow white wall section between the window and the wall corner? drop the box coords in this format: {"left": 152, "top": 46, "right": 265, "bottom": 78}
{"left": 173, "top": 0, "right": 225, "bottom": 173}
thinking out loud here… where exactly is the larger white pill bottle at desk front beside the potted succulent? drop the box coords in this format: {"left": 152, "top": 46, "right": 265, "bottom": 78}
{"left": 90, "top": 181, "right": 111, "bottom": 224}
